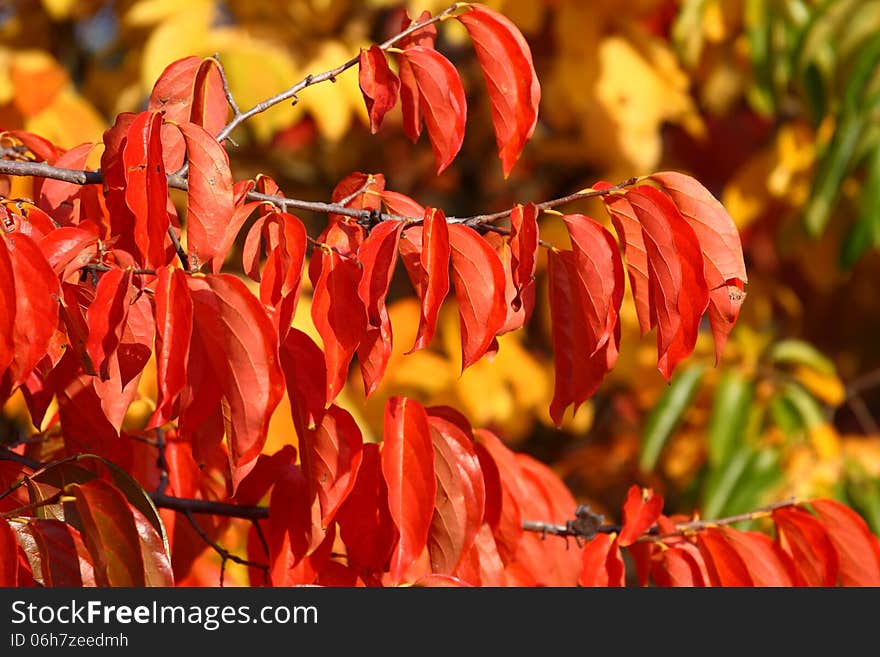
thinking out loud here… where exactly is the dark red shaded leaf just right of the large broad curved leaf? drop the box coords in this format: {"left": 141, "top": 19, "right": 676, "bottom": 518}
{"left": 280, "top": 328, "right": 327, "bottom": 436}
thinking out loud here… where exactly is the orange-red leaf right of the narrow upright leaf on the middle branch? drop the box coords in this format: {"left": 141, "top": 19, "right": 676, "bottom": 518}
{"left": 449, "top": 224, "right": 507, "bottom": 371}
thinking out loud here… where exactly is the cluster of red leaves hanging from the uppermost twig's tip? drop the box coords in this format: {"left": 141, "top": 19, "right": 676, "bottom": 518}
{"left": 359, "top": 4, "right": 541, "bottom": 176}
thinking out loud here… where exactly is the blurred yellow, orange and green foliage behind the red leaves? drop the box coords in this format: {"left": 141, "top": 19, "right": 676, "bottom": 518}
{"left": 0, "top": 0, "right": 880, "bottom": 576}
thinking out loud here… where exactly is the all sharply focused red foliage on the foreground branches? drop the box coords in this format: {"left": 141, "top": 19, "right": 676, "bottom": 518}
{"left": 0, "top": 4, "right": 880, "bottom": 586}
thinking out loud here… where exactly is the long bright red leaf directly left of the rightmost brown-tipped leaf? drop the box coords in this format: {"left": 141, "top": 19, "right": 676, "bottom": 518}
{"left": 626, "top": 185, "right": 709, "bottom": 380}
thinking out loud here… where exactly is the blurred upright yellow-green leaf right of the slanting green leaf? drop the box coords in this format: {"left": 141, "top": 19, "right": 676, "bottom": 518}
{"left": 708, "top": 370, "right": 755, "bottom": 467}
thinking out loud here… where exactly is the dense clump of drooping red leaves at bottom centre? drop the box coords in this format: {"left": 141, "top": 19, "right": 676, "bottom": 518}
{"left": 238, "top": 398, "right": 580, "bottom": 586}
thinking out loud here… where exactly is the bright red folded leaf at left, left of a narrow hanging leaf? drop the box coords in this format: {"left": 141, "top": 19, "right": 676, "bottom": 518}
{"left": 86, "top": 269, "right": 132, "bottom": 380}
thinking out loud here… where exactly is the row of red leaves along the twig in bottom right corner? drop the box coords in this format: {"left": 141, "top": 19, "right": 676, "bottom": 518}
{"left": 578, "top": 486, "right": 880, "bottom": 587}
